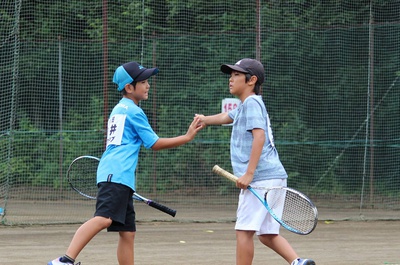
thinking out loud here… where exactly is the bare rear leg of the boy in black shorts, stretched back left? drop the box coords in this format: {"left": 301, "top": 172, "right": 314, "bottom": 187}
{"left": 66, "top": 216, "right": 112, "bottom": 259}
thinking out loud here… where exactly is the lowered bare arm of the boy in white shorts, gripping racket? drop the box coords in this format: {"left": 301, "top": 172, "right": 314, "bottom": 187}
{"left": 236, "top": 129, "right": 265, "bottom": 189}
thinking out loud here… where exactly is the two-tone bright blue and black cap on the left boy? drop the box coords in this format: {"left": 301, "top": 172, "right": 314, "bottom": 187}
{"left": 113, "top": 62, "right": 159, "bottom": 91}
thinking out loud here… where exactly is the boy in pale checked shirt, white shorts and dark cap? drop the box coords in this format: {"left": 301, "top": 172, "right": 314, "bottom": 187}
{"left": 196, "top": 59, "right": 315, "bottom": 265}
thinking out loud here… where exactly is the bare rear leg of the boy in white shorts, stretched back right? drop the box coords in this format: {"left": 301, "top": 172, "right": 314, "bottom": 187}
{"left": 258, "top": 234, "right": 298, "bottom": 264}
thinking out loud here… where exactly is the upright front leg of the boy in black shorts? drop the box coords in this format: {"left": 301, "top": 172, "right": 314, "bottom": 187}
{"left": 117, "top": 231, "right": 135, "bottom": 265}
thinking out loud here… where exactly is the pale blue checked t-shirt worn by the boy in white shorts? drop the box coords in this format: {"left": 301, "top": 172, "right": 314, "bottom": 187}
{"left": 228, "top": 95, "right": 287, "bottom": 182}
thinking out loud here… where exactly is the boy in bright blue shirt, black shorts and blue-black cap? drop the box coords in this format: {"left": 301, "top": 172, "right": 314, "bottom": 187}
{"left": 48, "top": 62, "right": 202, "bottom": 265}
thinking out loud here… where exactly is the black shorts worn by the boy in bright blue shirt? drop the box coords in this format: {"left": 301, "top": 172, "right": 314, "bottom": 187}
{"left": 94, "top": 182, "right": 136, "bottom": 232}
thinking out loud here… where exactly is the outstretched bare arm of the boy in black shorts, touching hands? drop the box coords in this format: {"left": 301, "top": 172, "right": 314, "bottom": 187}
{"left": 151, "top": 114, "right": 205, "bottom": 151}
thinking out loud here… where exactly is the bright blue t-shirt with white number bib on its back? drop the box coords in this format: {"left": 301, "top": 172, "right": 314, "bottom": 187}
{"left": 97, "top": 98, "right": 159, "bottom": 190}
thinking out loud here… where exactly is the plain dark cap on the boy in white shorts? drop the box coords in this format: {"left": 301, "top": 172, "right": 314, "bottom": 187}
{"left": 221, "top": 58, "right": 265, "bottom": 85}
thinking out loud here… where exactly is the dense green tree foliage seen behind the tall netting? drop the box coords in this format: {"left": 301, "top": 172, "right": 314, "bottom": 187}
{"left": 0, "top": 0, "right": 400, "bottom": 195}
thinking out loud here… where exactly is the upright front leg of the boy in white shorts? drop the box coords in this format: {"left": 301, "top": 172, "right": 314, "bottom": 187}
{"left": 236, "top": 230, "right": 254, "bottom": 265}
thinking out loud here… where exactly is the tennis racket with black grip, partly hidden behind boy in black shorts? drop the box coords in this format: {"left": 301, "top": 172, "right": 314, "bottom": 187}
{"left": 67, "top": 156, "right": 176, "bottom": 217}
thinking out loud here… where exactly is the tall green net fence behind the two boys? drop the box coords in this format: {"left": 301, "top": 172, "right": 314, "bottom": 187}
{"left": 0, "top": 0, "right": 400, "bottom": 224}
